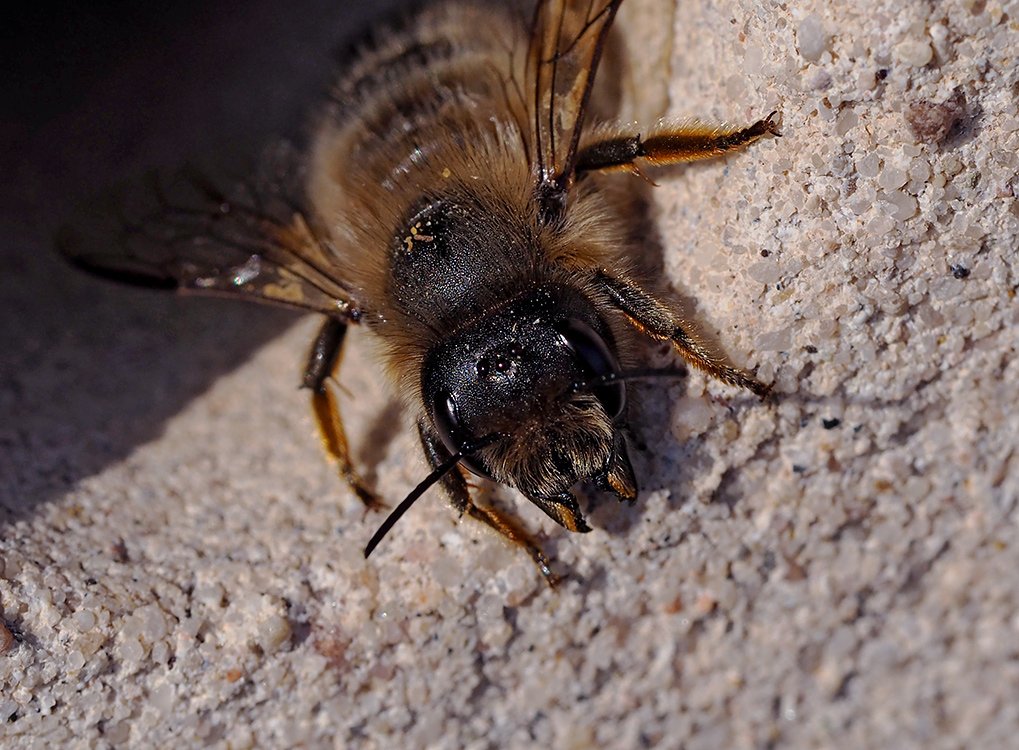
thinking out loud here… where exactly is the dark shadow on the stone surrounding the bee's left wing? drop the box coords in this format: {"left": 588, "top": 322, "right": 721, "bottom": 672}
{"left": 0, "top": 0, "right": 406, "bottom": 524}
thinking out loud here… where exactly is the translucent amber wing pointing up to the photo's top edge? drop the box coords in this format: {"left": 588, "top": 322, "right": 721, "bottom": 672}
{"left": 526, "top": 0, "right": 623, "bottom": 206}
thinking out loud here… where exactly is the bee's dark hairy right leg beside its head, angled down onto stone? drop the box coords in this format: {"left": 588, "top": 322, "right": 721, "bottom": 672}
{"left": 595, "top": 271, "right": 771, "bottom": 398}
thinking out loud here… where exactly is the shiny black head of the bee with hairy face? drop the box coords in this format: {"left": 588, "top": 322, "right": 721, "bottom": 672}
{"left": 422, "top": 285, "right": 629, "bottom": 507}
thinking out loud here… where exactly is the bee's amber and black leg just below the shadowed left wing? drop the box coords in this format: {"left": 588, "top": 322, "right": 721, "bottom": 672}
{"left": 302, "top": 318, "right": 383, "bottom": 508}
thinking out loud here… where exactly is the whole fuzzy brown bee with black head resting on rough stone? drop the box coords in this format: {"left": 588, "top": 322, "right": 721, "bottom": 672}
{"left": 60, "top": 0, "right": 780, "bottom": 583}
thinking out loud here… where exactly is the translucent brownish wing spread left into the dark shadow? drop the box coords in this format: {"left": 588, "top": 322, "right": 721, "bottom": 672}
{"left": 57, "top": 146, "right": 359, "bottom": 316}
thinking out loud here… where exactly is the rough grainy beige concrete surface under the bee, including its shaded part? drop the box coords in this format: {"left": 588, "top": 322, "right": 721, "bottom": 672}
{"left": 0, "top": 0, "right": 1019, "bottom": 748}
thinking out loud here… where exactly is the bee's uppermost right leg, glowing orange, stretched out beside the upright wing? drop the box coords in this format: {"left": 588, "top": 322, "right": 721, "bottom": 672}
{"left": 577, "top": 112, "right": 782, "bottom": 172}
